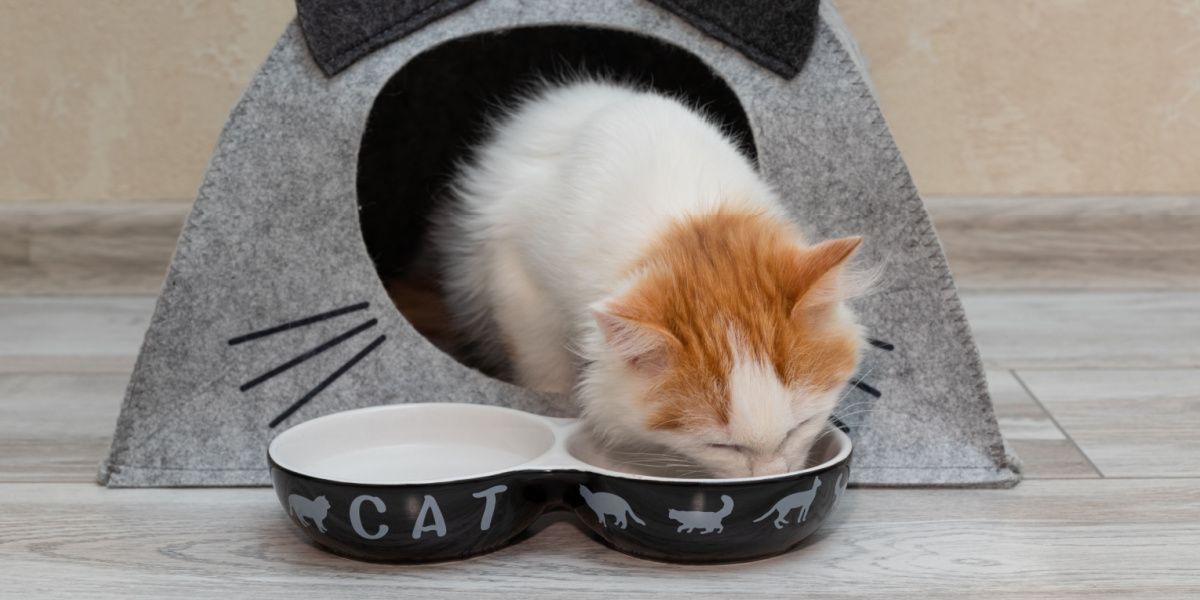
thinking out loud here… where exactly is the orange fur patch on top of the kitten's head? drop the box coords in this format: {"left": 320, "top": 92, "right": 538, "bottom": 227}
{"left": 607, "top": 211, "right": 860, "bottom": 430}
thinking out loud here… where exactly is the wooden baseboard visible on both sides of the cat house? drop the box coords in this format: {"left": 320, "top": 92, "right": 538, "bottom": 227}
{"left": 0, "top": 196, "right": 1200, "bottom": 295}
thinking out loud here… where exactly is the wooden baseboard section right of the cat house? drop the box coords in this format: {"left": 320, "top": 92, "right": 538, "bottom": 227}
{"left": 926, "top": 196, "right": 1200, "bottom": 289}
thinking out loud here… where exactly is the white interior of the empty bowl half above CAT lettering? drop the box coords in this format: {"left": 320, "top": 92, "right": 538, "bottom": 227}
{"left": 269, "top": 403, "right": 554, "bottom": 485}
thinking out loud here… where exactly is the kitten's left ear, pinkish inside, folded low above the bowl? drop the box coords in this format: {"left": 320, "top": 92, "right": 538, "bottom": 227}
{"left": 590, "top": 301, "right": 679, "bottom": 377}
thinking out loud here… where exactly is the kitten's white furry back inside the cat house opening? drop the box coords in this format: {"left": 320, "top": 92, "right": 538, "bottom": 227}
{"left": 437, "top": 80, "right": 776, "bottom": 362}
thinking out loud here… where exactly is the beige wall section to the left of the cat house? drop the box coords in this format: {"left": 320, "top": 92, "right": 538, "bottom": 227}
{"left": 0, "top": 0, "right": 294, "bottom": 202}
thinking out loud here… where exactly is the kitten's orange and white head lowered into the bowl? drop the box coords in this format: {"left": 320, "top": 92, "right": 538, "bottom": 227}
{"left": 581, "top": 214, "right": 862, "bottom": 478}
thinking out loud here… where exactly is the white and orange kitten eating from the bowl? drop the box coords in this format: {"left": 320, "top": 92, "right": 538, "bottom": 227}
{"left": 438, "top": 80, "right": 862, "bottom": 476}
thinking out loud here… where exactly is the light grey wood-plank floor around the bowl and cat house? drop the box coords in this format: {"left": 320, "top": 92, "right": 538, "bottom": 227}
{"left": 0, "top": 200, "right": 1200, "bottom": 600}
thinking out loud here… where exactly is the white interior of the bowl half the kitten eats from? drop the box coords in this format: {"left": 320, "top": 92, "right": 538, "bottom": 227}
{"left": 566, "top": 425, "right": 851, "bottom": 484}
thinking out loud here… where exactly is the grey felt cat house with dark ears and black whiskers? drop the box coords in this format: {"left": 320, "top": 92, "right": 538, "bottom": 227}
{"left": 100, "top": 0, "right": 1018, "bottom": 487}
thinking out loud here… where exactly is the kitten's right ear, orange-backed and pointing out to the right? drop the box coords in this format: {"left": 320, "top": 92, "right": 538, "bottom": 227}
{"left": 792, "top": 235, "right": 870, "bottom": 318}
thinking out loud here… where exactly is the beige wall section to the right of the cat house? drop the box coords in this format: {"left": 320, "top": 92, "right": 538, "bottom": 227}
{"left": 838, "top": 0, "right": 1200, "bottom": 194}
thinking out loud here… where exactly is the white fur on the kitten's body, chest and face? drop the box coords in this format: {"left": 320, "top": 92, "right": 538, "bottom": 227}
{"left": 439, "top": 82, "right": 835, "bottom": 470}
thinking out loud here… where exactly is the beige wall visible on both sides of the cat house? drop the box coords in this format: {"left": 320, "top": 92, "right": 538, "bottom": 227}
{"left": 0, "top": 0, "right": 1200, "bottom": 202}
